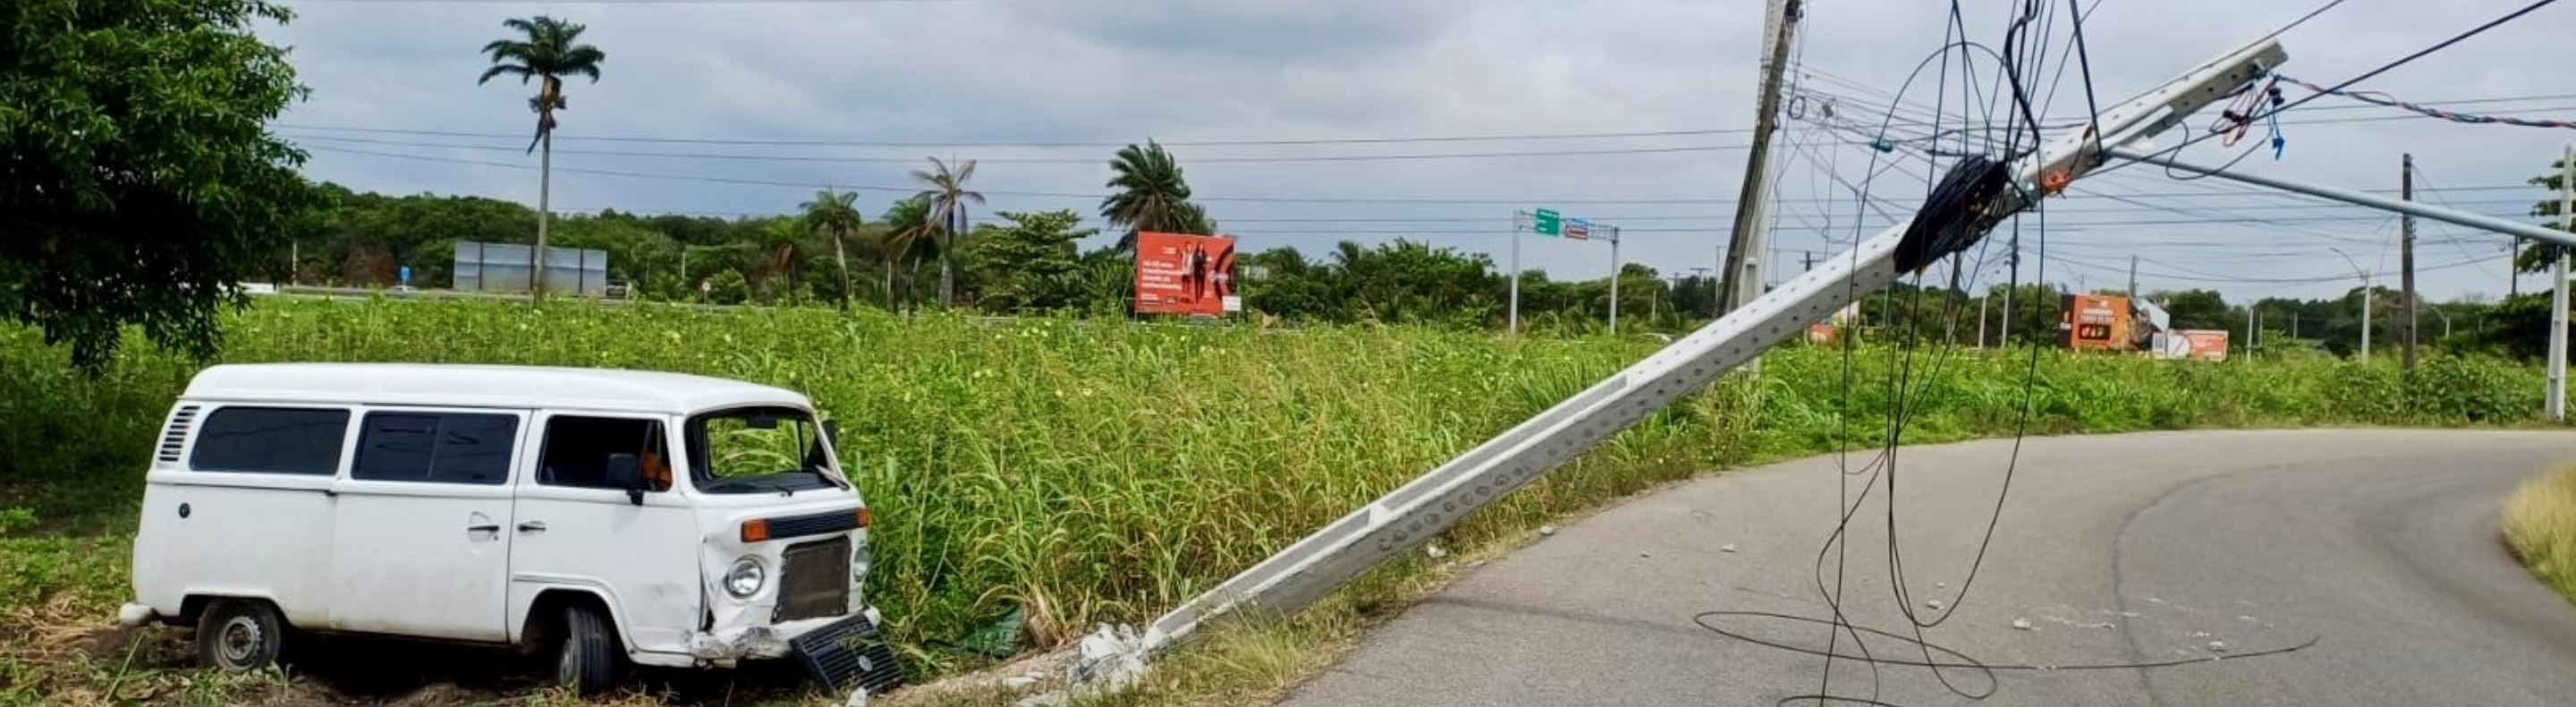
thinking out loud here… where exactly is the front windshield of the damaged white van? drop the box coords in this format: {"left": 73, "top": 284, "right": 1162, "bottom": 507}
{"left": 688, "top": 408, "right": 843, "bottom": 496}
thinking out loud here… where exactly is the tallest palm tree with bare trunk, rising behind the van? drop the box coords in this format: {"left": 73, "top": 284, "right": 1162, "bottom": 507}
{"left": 474, "top": 15, "right": 608, "bottom": 302}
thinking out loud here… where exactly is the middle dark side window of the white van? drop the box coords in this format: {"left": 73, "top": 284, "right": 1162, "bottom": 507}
{"left": 348, "top": 413, "right": 518, "bottom": 485}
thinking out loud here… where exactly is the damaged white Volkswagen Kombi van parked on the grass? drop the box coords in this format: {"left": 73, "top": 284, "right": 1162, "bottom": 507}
{"left": 118, "top": 364, "right": 902, "bottom": 692}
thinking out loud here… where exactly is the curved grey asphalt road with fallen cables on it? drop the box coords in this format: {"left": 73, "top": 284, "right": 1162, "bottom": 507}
{"left": 1285, "top": 430, "right": 2576, "bottom": 707}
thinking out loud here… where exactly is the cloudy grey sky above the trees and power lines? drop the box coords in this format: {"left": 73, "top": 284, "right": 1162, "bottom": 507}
{"left": 266, "top": 0, "right": 2576, "bottom": 299}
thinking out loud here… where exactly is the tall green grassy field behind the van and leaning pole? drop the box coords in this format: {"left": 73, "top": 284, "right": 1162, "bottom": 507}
{"left": 0, "top": 299, "right": 2540, "bottom": 704}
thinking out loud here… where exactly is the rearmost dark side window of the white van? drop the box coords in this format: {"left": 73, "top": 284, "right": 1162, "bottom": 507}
{"left": 188, "top": 408, "right": 348, "bottom": 477}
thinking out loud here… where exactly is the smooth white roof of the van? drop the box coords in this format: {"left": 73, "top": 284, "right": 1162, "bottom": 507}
{"left": 182, "top": 364, "right": 811, "bottom": 415}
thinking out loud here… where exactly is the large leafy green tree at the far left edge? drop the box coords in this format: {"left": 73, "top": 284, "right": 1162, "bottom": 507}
{"left": 0, "top": 0, "right": 317, "bottom": 374}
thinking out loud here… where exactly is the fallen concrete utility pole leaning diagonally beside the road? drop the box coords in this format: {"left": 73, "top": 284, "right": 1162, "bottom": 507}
{"left": 1141, "top": 38, "right": 2285, "bottom": 652}
